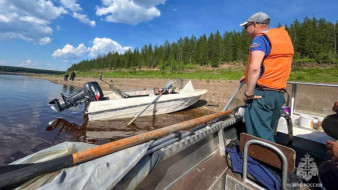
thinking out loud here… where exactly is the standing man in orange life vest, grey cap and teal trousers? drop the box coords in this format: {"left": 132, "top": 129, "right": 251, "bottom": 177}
{"left": 240, "top": 12, "right": 294, "bottom": 142}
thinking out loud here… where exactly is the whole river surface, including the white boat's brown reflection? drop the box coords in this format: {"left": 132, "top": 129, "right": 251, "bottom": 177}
{"left": 0, "top": 74, "right": 205, "bottom": 165}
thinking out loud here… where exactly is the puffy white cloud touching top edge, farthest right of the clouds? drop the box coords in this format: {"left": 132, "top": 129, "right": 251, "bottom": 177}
{"left": 96, "top": 0, "right": 166, "bottom": 25}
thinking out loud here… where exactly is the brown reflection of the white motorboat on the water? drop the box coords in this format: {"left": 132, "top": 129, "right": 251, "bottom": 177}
{"left": 46, "top": 100, "right": 210, "bottom": 145}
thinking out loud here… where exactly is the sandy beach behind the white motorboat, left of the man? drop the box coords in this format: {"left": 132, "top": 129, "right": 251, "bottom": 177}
{"left": 30, "top": 75, "right": 245, "bottom": 112}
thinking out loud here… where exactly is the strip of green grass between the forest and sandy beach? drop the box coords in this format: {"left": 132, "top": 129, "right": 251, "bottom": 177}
{"left": 67, "top": 66, "right": 338, "bottom": 83}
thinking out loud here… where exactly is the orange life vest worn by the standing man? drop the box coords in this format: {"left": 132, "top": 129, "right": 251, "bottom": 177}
{"left": 245, "top": 27, "right": 294, "bottom": 89}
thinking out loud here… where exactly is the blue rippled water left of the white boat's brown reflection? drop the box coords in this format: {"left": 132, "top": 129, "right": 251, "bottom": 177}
{"left": 0, "top": 74, "right": 84, "bottom": 164}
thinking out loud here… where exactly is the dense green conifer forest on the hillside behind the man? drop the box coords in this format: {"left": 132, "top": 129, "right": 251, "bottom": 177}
{"left": 68, "top": 17, "right": 338, "bottom": 71}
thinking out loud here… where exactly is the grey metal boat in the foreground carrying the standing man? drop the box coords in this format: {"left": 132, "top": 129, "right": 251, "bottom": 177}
{"left": 0, "top": 82, "right": 338, "bottom": 189}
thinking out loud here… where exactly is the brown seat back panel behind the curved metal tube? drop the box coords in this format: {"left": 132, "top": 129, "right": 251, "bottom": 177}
{"left": 239, "top": 133, "right": 296, "bottom": 173}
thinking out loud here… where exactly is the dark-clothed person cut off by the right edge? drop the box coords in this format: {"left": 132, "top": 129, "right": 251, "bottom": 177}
{"left": 319, "top": 102, "right": 338, "bottom": 190}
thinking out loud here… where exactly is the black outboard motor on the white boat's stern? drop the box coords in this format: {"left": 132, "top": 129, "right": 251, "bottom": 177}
{"left": 49, "top": 82, "right": 103, "bottom": 112}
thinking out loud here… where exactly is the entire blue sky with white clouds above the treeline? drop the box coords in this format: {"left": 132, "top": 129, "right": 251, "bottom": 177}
{"left": 0, "top": 0, "right": 338, "bottom": 70}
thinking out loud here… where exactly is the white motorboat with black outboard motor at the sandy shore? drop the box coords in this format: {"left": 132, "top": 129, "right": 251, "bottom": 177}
{"left": 50, "top": 81, "right": 207, "bottom": 121}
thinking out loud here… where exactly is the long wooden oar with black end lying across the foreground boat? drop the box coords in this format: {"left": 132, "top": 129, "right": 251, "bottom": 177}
{"left": 0, "top": 110, "right": 232, "bottom": 188}
